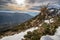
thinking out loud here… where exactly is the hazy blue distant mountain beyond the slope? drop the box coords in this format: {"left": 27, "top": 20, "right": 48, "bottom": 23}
{"left": 0, "top": 12, "right": 33, "bottom": 31}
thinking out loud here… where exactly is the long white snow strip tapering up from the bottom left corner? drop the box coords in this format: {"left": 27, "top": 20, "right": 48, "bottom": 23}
{"left": 0, "top": 27, "right": 38, "bottom": 40}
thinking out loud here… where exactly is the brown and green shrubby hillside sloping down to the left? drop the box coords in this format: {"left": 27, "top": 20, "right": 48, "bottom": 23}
{"left": 0, "top": 7, "right": 60, "bottom": 40}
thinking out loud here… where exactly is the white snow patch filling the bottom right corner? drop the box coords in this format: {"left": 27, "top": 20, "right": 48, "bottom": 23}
{"left": 40, "top": 27, "right": 60, "bottom": 40}
